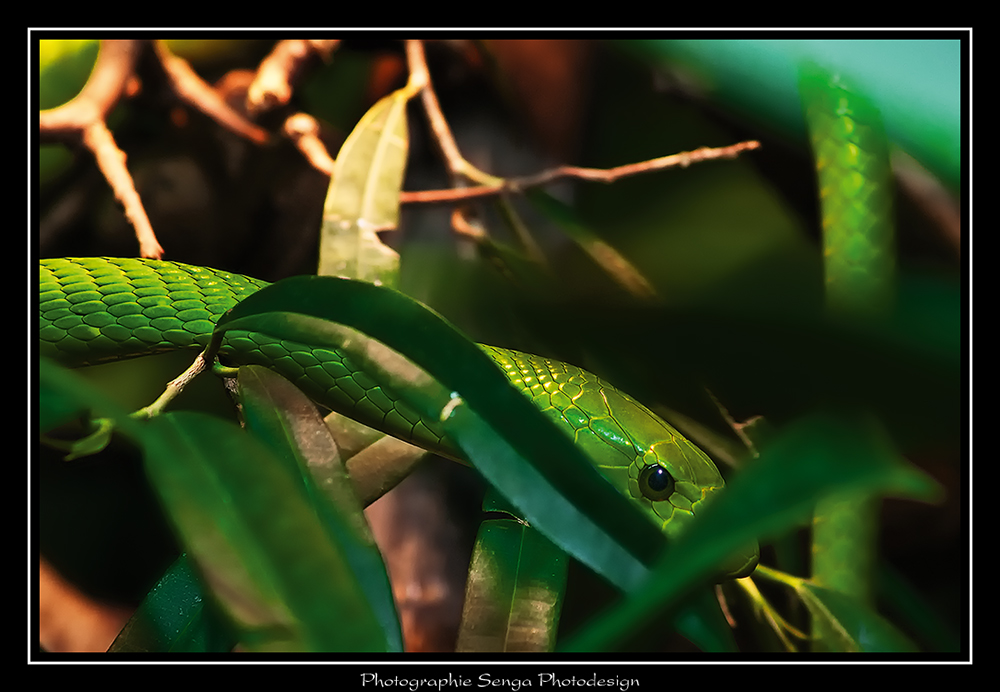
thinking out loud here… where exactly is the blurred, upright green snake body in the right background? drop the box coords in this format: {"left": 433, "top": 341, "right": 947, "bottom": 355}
{"left": 799, "top": 64, "right": 897, "bottom": 636}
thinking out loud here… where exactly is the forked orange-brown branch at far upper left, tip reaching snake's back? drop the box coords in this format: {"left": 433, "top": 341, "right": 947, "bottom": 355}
{"left": 38, "top": 41, "right": 163, "bottom": 259}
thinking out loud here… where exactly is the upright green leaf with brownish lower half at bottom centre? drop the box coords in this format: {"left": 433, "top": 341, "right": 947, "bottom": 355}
{"left": 456, "top": 506, "right": 569, "bottom": 653}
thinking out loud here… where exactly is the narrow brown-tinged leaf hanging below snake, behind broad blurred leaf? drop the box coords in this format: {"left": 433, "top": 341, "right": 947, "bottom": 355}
{"left": 237, "top": 365, "right": 403, "bottom": 651}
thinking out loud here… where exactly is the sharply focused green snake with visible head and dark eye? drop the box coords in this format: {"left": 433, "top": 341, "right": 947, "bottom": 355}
{"left": 39, "top": 257, "right": 758, "bottom": 577}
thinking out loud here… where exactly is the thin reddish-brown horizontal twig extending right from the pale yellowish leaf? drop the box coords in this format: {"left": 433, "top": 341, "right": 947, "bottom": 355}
{"left": 399, "top": 140, "right": 761, "bottom": 204}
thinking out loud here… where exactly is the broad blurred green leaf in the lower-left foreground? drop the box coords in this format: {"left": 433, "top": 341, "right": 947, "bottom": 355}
{"left": 142, "top": 412, "right": 387, "bottom": 651}
